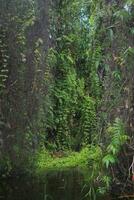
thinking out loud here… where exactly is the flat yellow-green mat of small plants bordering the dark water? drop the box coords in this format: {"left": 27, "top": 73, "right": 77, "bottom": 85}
{"left": 36, "top": 147, "right": 90, "bottom": 172}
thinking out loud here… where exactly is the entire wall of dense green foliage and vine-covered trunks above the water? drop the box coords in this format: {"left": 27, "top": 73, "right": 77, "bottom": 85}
{"left": 0, "top": 0, "right": 134, "bottom": 199}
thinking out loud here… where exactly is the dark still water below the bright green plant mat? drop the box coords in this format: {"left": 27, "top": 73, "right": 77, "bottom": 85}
{"left": 0, "top": 170, "right": 109, "bottom": 200}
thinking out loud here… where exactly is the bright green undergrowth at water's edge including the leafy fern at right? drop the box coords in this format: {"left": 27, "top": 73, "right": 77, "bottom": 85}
{"left": 35, "top": 118, "right": 128, "bottom": 200}
